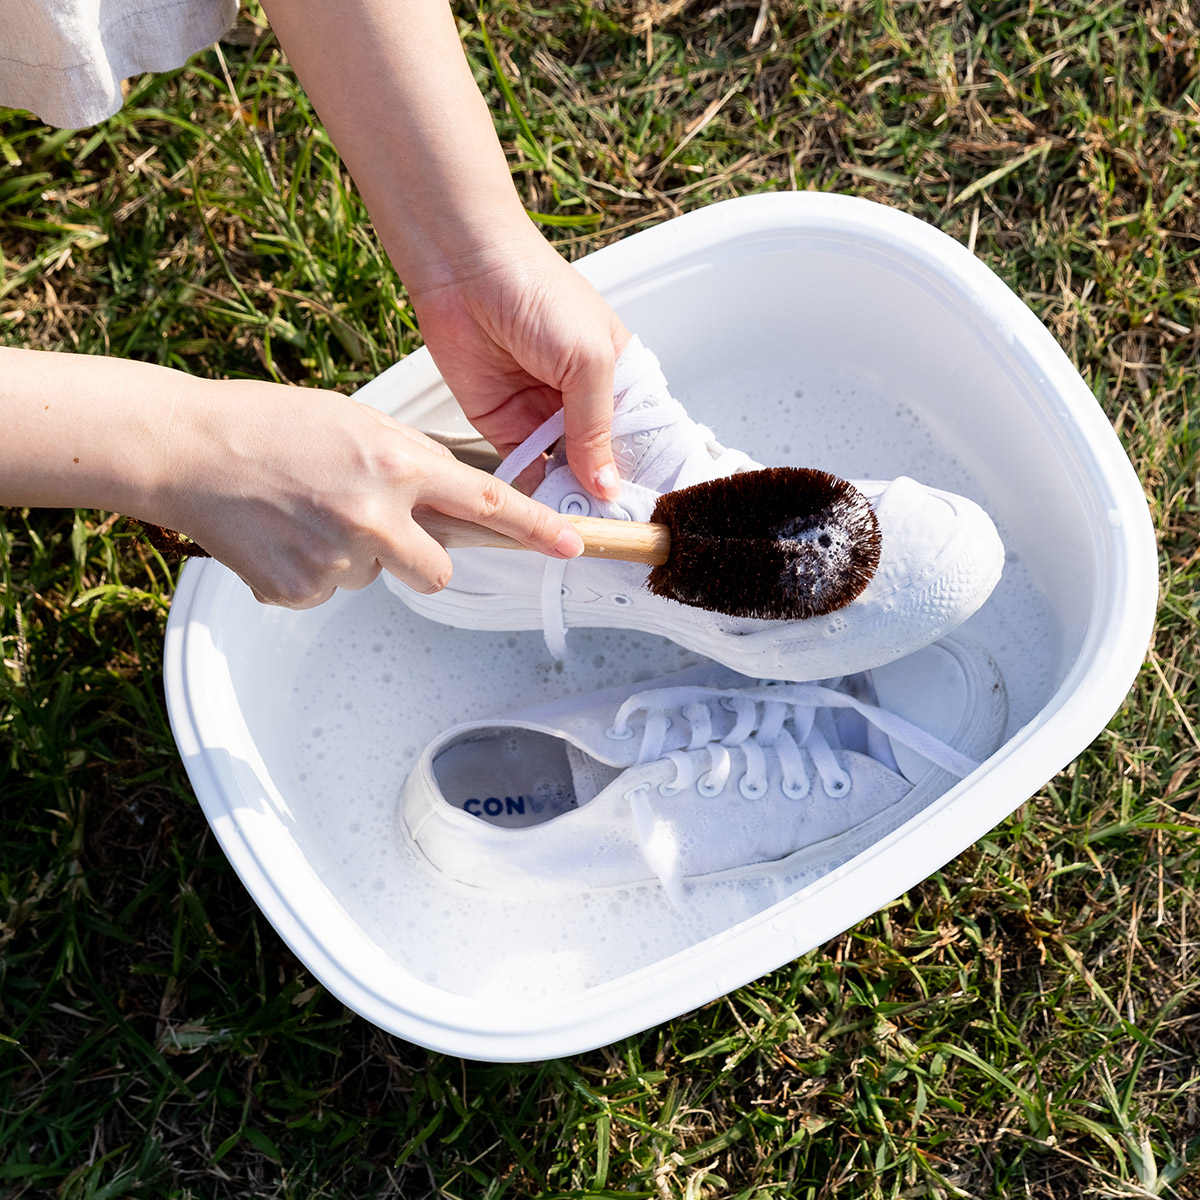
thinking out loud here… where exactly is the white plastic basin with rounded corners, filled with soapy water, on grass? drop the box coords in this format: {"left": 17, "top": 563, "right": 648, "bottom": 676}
{"left": 166, "top": 193, "right": 1157, "bottom": 1061}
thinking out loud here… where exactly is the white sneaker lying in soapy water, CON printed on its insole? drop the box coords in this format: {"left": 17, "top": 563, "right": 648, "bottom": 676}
{"left": 402, "top": 638, "right": 1008, "bottom": 904}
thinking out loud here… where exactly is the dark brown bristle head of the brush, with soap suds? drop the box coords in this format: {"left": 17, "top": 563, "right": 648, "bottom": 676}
{"left": 648, "top": 467, "right": 882, "bottom": 620}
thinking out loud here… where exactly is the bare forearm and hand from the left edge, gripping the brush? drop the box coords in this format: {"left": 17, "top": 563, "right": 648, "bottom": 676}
{"left": 0, "top": 347, "right": 582, "bottom": 608}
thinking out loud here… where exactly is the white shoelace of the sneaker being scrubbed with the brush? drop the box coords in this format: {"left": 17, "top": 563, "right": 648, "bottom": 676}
{"left": 496, "top": 370, "right": 751, "bottom": 662}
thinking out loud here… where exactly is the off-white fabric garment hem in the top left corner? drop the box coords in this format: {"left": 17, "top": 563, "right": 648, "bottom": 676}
{"left": 0, "top": 0, "right": 238, "bottom": 128}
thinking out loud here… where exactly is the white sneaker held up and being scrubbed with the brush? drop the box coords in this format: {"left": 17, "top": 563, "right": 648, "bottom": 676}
{"left": 384, "top": 338, "right": 1004, "bottom": 680}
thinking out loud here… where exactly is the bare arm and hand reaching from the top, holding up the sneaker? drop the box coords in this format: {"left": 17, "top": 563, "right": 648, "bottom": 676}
{"left": 253, "top": 0, "right": 629, "bottom": 498}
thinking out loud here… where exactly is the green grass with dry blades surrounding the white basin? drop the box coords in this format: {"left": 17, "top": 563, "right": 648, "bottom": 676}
{"left": 0, "top": 0, "right": 1200, "bottom": 1200}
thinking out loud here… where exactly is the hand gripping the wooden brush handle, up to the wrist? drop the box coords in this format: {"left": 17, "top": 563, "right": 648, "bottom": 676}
{"left": 157, "top": 380, "right": 583, "bottom": 608}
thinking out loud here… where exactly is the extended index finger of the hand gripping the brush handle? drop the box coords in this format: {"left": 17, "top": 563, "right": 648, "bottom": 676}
{"left": 420, "top": 462, "right": 583, "bottom": 558}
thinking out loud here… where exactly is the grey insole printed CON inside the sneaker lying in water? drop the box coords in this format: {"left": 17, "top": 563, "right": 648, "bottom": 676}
{"left": 433, "top": 728, "right": 620, "bottom": 829}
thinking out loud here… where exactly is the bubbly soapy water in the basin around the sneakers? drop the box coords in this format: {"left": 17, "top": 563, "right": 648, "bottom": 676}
{"left": 278, "top": 367, "right": 1069, "bottom": 1003}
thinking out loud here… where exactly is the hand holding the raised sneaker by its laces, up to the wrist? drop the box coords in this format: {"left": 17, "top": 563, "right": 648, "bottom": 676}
{"left": 410, "top": 234, "right": 630, "bottom": 499}
